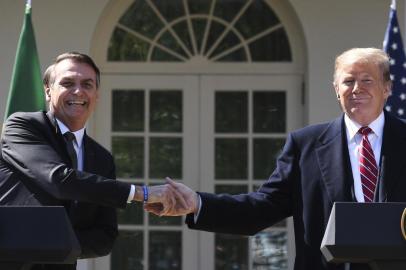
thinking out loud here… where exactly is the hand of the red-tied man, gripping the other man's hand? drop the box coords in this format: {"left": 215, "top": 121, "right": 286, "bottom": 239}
{"left": 144, "top": 178, "right": 199, "bottom": 216}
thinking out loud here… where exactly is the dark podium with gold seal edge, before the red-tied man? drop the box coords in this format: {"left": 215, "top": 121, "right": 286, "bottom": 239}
{"left": 321, "top": 202, "right": 406, "bottom": 270}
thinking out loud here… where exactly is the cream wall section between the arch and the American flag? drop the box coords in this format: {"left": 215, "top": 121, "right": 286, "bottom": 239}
{"left": 290, "top": 0, "right": 405, "bottom": 123}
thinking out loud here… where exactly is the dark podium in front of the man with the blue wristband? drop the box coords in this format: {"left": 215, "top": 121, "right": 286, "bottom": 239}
{"left": 0, "top": 206, "right": 80, "bottom": 270}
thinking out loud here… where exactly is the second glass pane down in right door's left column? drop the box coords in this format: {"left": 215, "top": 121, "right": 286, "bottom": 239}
{"left": 215, "top": 139, "right": 248, "bottom": 179}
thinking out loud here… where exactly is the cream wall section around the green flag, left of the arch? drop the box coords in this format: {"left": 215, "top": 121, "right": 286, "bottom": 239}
{"left": 0, "top": 0, "right": 108, "bottom": 122}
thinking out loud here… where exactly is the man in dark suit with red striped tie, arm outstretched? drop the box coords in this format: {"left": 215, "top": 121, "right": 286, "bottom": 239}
{"left": 146, "top": 48, "right": 406, "bottom": 270}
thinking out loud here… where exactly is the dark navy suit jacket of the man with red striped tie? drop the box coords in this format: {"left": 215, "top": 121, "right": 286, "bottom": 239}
{"left": 186, "top": 110, "right": 406, "bottom": 270}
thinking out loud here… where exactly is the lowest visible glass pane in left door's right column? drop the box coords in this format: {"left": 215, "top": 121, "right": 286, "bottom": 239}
{"left": 149, "top": 231, "right": 182, "bottom": 270}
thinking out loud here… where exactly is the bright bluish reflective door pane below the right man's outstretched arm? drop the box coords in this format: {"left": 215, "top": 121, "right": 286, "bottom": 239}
{"left": 251, "top": 231, "right": 288, "bottom": 270}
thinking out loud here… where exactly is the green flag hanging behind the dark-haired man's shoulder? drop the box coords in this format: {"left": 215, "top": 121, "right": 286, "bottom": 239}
{"left": 4, "top": 1, "right": 46, "bottom": 119}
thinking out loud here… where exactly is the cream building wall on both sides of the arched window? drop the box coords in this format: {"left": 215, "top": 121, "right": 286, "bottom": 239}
{"left": 0, "top": 0, "right": 405, "bottom": 123}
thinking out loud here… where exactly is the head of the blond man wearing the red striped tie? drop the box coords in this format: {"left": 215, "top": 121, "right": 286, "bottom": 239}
{"left": 334, "top": 49, "right": 392, "bottom": 126}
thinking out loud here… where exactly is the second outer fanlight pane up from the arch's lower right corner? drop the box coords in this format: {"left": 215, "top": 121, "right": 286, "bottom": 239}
{"left": 235, "top": 0, "right": 280, "bottom": 39}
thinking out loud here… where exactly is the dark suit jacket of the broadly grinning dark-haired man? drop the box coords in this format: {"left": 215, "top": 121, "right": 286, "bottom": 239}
{"left": 0, "top": 112, "right": 130, "bottom": 269}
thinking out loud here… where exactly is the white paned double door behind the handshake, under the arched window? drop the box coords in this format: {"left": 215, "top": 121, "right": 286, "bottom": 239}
{"left": 92, "top": 75, "right": 303, "bottom": 270}
